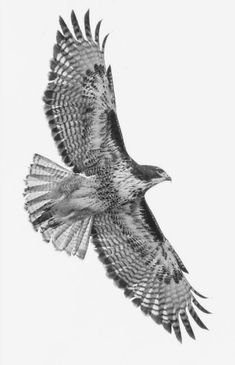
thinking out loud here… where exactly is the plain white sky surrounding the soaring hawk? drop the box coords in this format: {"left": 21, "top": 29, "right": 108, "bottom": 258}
{"left": 0, "top": 0, "right": 235, "bottom": 365}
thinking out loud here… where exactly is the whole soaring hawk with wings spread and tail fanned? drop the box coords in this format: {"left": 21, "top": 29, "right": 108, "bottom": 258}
{"left": 25, "top": 11, "right": 209, "bottom": 341}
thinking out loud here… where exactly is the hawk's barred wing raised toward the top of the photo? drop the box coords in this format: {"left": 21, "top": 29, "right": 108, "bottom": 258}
{"left": 44, "top": 11, "right": 127, "bottom": 172}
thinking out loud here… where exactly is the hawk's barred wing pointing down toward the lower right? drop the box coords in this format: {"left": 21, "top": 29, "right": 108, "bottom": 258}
{"left": 92, "top": 198, "right": 209, "bottom": 341}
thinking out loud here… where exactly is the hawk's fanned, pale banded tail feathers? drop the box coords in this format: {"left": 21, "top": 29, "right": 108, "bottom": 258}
{"left": 24, "top": 154, "right": 93, "bottom": 258}
